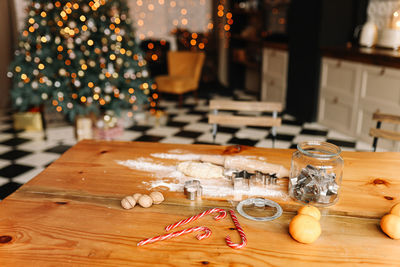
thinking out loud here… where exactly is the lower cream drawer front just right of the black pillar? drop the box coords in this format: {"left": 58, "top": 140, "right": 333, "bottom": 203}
{"left": 318, "top": 93, "right": 354, "bottom": 134}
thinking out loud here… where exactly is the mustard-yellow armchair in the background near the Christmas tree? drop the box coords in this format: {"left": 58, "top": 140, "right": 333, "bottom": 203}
{"left": 155, "top": 51, "right": 205, "bottom": 106}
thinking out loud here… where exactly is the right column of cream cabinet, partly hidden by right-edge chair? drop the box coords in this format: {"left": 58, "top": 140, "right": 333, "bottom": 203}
{"left": 356, "top": 65, "right": 400, "bottom": 151}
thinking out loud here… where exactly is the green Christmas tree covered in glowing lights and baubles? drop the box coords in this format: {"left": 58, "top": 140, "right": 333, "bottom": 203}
{"left": 9, "top": 0, "right": 157, "bottom": 120}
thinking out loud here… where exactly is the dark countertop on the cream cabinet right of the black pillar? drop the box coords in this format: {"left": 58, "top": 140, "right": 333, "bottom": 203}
{"left": 322, "top": 47, "right": 400, "bottom": 68}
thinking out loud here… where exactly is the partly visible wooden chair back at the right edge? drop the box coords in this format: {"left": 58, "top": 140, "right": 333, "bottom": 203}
{"left": 369, "top": 110, "right": 400, "bottom": 152}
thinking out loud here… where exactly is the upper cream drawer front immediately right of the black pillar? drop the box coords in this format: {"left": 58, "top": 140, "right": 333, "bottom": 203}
{"left": 321, "top": 58, "right": 360, "bottom": 96}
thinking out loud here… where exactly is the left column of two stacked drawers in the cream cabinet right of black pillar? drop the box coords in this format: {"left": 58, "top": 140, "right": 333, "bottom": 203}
{"left": 318, "top": 58, "right": 361, "bottom": 135}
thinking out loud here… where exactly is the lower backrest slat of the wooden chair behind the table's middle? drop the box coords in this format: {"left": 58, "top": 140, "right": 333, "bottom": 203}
{"left": 208, "top": 114, "right": 282, "bottom": 127}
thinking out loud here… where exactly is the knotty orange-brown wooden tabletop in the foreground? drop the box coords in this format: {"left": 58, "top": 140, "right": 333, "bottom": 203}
{"left": 0, "top": 141, "right": 400, "bottom": 266}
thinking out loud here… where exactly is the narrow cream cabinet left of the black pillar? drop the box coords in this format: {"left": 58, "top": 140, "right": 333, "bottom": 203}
{"left": 261, "top": 48, "right": 288, "bottom": 107}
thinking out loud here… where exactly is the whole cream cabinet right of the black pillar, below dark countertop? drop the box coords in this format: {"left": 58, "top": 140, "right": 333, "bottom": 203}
{"left": 318, "top": 58, "right": 400, "bottom": 150}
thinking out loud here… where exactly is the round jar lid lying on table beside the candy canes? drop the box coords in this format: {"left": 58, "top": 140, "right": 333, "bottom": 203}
{"left": 236, "top": 198, "right": 282, "bottom": 222}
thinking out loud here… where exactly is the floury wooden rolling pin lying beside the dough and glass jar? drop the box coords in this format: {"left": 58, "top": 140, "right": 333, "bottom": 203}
{"left": 200, "top": 155, "right": 289, "bottom": 178}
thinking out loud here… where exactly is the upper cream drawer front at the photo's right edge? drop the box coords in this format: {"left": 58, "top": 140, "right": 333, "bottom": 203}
{"left": 360, "top": 66, "right": 400, "bottom": 107}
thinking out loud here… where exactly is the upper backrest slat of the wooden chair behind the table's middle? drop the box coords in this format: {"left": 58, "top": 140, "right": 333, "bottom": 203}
{"left": 210, "top": 99, "right": 282, "bottom": 112}
